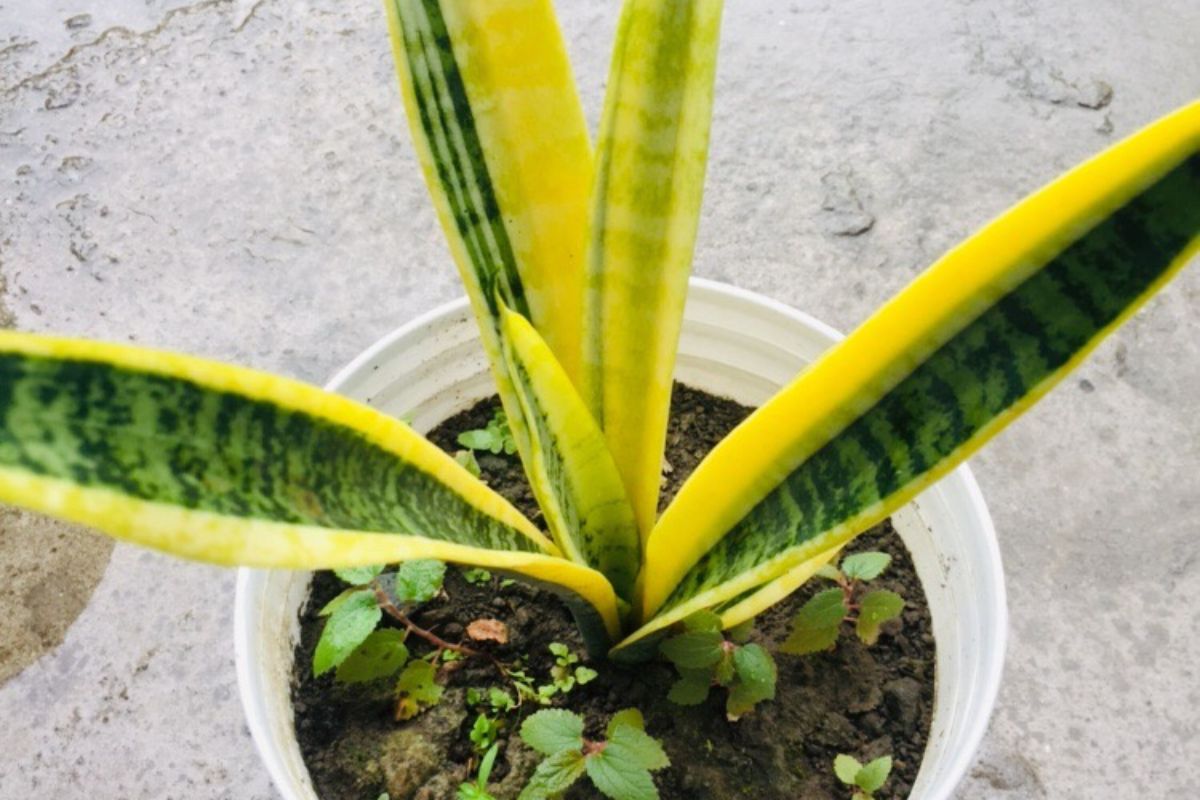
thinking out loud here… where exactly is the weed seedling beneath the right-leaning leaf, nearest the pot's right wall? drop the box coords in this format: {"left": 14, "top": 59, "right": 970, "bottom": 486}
{"left": 780, "top": 553, "right": 904, "bottom": 655}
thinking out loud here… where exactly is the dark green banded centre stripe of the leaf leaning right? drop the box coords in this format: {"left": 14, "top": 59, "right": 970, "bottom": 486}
{"left": 666, "top": 155, "right": 1200, "bottom": 608}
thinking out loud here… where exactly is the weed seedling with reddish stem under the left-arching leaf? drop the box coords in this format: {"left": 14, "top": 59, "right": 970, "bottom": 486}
{"left": 312, "top": 559, "right": 460, "bottom": 720}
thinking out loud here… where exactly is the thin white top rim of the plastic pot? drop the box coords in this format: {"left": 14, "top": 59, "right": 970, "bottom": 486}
{"left": 234, "top": 277, "right": 1008, "bottom": 792}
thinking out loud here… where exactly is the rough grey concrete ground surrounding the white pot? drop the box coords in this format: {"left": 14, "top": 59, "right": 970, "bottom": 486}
{"left": 0, "top": 0, "right": 1200, "bottom": 800}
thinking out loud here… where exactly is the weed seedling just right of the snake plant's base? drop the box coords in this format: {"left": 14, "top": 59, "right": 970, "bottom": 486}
{"left": 660, "top": 610, "right": 776, "bottom": 721}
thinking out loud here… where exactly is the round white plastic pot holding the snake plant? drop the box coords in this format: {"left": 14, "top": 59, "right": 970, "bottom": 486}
{"left": 235, "top": 279, "right": 1007, "bottom": 800}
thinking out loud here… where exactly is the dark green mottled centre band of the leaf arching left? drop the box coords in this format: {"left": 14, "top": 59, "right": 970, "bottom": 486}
{"left": 0, "top": 351, "right": 540, "bottom": 552}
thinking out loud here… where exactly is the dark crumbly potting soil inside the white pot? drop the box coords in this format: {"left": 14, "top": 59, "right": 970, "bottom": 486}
{"left": 293, "top": 385, "right": 934, "bottom": 800}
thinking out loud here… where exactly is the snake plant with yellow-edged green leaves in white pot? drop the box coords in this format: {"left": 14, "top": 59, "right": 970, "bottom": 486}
{"left": 0, "top": 0, "right": 1200, "bottom": 656}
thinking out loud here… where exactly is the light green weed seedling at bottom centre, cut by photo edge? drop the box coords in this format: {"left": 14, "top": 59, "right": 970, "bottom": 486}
{"left": 517, "top": 709, "right": 671, "bottom": 800}
